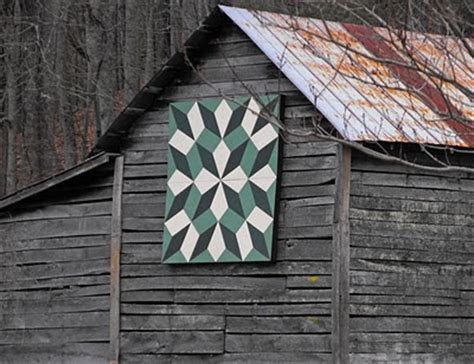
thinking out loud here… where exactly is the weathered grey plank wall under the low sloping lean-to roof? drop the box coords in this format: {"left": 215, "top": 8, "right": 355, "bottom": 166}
{"left": 0, "top": 166, "right": 113, "bottom": 364}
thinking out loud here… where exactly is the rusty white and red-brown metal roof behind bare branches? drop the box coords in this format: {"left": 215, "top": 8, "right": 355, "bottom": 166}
{"left": 220, "top": 6, "right": 474, "bottom": 147}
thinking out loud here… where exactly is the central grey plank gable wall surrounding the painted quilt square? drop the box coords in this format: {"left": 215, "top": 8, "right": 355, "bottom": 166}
{"left": 120, "top": 27, "right": 337, "bottom": 363}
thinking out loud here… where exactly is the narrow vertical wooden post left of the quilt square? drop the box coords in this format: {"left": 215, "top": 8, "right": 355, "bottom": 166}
{"left": 109, "top": 156, "right": 124, "bottom": 364}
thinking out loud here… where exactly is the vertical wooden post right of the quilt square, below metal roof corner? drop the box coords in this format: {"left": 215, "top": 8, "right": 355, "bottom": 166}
{"left": 331, "top": 145, "right": 351, "bottom": 364}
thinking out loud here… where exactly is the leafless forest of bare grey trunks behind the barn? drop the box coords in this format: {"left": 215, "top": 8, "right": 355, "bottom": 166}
{"left": 0, "top": 0, "right": 474, "bottom": 195}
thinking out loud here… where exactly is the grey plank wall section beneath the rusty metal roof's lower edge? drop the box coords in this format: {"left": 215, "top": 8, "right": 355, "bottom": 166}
{"left": 350, "top": 149, "right": 474, "bottom": 363}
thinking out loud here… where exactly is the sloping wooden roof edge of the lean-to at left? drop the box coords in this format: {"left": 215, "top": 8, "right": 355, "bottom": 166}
{"left": 0, "top": 153, "right": 116, "bottom": 210}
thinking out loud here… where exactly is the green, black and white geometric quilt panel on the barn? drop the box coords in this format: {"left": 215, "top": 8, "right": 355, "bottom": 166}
{"left": 162, "top": 95, "right": 281, "bottom": 264}
